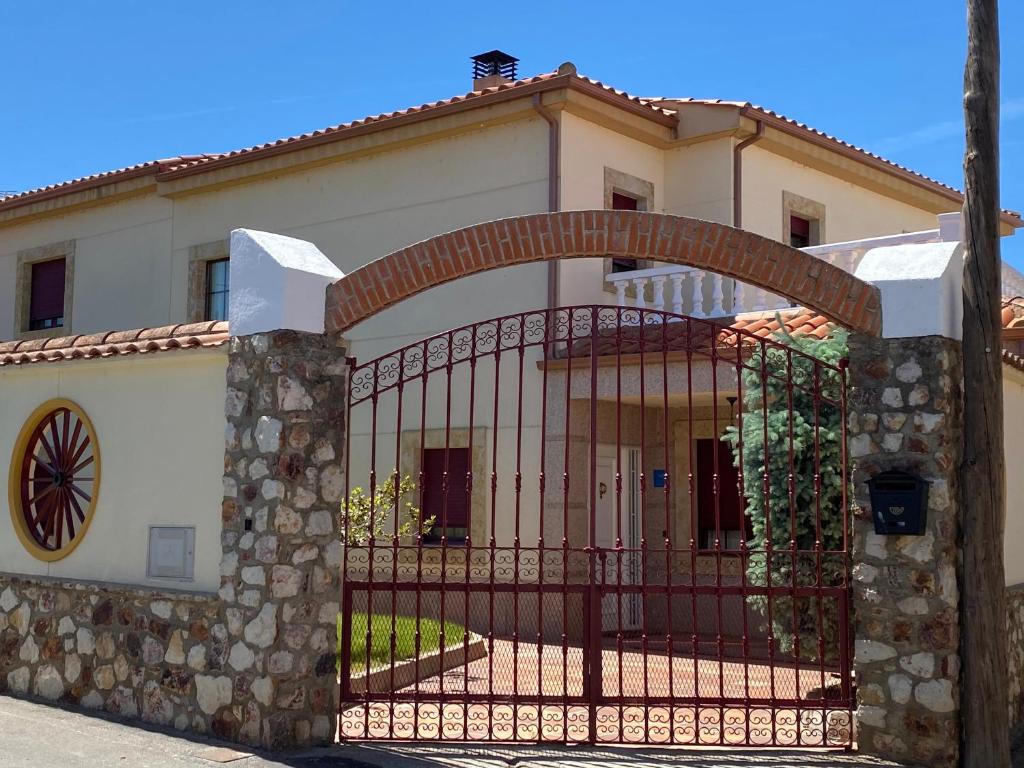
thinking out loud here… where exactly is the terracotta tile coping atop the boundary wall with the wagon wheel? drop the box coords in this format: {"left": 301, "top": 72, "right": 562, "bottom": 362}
{"left": 0, "top": 321, "right": 230, "bottom": 367}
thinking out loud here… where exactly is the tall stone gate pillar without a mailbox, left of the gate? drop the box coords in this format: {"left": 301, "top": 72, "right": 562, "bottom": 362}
{"left": 218, "top": 331, "right": 348, "bottom": 748}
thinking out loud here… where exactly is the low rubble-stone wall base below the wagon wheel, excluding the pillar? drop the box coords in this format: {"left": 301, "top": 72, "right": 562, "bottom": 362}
{"left": 0, "top": 574, "right": 220, "bottom": 733}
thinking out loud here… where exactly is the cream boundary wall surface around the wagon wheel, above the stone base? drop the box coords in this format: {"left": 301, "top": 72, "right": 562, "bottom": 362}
{"left": 0, "top": 347, "right": 227, "bottom": 592}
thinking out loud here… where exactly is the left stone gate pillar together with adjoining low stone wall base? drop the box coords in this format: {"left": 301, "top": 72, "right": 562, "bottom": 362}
{"left": 0, "top": 331, "right": 347, "bottom": 748}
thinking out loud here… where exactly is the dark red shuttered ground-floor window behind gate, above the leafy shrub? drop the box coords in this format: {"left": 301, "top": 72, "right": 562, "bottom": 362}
{"left": 420, "top": 447, "right": 470, "bottom": 544}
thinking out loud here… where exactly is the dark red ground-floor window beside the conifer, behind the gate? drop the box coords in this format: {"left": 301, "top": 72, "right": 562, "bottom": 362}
{"left": 695, "top": 438, "right": 753, "bottom": 550}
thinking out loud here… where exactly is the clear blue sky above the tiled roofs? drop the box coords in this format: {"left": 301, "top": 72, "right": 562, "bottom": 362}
{"left": 0, "top": 0, "right": 1024, "bottom": 269}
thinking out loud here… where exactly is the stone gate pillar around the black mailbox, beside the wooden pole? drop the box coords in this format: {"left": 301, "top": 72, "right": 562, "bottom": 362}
{"left": 848, "top": 335, "right": 963, "bottom": 768}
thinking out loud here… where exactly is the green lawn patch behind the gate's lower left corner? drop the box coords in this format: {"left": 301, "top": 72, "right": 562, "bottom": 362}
{"left": 338, "top": 611, "right": 465, "bottom": 675}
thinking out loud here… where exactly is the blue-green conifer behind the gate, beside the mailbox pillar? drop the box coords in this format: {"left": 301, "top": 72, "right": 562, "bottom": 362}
{"left": 724, "top": 330, "right": 847, "bottom": 660}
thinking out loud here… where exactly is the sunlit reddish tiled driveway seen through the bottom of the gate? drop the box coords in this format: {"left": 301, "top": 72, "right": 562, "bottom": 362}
{"left": 341, "top": 640, "right": 851, "bottom": 746}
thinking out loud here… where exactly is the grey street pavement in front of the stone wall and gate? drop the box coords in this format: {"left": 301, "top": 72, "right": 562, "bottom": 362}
{"left": 0, "top": 696, "right": 905, "bottom": 768}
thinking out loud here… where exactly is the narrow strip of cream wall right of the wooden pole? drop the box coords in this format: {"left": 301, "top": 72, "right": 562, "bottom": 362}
{"left": 1002, "top": 366, "right": 1024, "bottom": 586}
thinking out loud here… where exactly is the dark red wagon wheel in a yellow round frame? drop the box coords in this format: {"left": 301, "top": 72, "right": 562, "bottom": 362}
{"left": 10, "top": 400, "right": 99, "bottom": 560}
